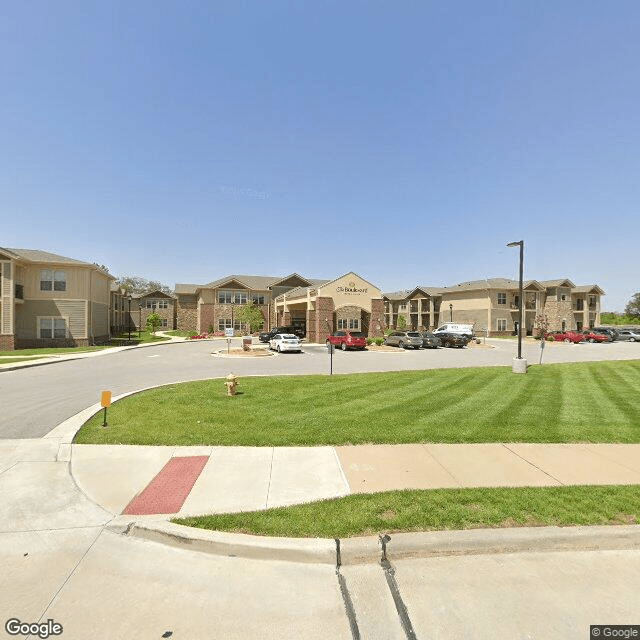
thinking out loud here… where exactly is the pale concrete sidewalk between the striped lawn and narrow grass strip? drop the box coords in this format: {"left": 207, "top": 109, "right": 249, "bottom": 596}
{"left": 70, "top": 443, "right": 640, "bottom": 518}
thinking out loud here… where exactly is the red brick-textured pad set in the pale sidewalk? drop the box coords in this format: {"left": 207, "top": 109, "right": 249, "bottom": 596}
{"left": 122, "top": 456, "right": 209, "bottom": 516}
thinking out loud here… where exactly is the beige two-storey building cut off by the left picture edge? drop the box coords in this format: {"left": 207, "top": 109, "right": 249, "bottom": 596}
{"left": 0, "top": 248, "right": 114, "bottom": 350}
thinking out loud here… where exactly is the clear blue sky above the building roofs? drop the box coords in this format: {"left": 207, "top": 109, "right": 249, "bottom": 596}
{"left": 0, "top": 0, "right": 640, "bottom": 310}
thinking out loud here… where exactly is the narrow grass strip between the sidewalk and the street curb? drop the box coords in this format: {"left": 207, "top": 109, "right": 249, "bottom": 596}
{"left": 173, "top": 485, "right": 640, "bottom": 538}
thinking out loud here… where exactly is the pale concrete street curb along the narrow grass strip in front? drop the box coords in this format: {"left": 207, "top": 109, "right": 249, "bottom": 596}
{"left": 107, "top": 516, "right": 640, "bottom": 565}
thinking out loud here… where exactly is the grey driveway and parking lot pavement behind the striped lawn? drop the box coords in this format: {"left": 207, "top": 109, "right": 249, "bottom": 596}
{"left": 0, "top": 340, "right": 640, "bottom": 439}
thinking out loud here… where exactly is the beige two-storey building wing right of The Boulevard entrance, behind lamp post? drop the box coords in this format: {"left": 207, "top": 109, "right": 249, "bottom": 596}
{"left": 384, "top": 278, "right": 604, "bottom": 336}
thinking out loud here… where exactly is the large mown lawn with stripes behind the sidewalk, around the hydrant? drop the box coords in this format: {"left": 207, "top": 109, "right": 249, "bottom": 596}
{"left": 76, "top": 361, "right": 640, "bottom": 446}
